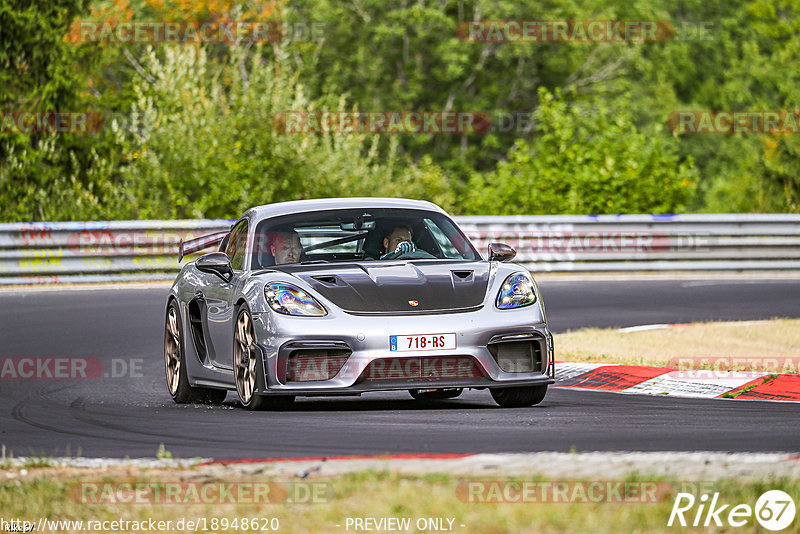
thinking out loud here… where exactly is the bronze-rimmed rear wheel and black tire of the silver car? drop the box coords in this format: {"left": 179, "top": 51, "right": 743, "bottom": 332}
{"left": 164, "top": 300, "right": 228, "bottom": 404}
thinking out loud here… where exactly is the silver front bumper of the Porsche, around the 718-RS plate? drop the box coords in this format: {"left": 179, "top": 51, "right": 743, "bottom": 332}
{"left": 253, "top": 306, "right": 555, "bottom": 395}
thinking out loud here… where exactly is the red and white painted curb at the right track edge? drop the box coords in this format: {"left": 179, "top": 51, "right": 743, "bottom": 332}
{"left": 556, "top": 362, "right": 800, "bottom": 401}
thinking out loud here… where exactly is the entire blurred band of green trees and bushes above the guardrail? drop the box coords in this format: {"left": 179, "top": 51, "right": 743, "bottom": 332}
{"left": 0, "top": 0, "right": 800, "bottom": 221}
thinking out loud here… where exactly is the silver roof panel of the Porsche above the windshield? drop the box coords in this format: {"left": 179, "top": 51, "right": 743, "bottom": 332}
{"left": 246, "top": 197, "right": 446, "bottom": 220}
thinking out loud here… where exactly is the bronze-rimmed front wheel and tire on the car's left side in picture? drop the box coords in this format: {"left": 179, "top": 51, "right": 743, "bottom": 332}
{"left": 233, "top": 306, "right": 294, "bottom": 411}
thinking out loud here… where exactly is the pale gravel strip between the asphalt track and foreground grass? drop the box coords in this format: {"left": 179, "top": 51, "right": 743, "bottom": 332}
{"left": 0, "top": 452, "right": 800, "bottom": 481}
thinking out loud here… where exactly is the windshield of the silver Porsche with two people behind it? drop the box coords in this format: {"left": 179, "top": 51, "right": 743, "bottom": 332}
{"left": 252, "top": 209, "right": 481, "bottom": 269}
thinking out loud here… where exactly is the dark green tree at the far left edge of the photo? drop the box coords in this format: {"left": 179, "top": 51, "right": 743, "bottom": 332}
{"left": 0, "top": 0, "right": 125, "bottom": 221}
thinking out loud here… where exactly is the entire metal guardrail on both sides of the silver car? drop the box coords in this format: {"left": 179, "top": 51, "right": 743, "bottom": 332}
{"left": 0, "top": 214, "right": 800, "bottom": 284}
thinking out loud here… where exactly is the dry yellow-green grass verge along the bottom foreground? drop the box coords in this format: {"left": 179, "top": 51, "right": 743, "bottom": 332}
{"left": 0, "top": 469, "right": 800, "bottom": 534}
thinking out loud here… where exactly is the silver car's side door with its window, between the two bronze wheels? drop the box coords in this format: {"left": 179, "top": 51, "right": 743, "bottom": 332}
{"left": 203, "top": 219, "right": 249, "bottom": 369}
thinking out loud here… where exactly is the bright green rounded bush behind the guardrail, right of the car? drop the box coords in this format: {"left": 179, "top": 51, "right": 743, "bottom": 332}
{"left": 465, "top": 89, "right": 695, "bottom": 214}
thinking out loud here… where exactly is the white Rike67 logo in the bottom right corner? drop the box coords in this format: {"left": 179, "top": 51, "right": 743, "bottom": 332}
{"left": 667, "top": 490, "right": 796, "bottom": 531}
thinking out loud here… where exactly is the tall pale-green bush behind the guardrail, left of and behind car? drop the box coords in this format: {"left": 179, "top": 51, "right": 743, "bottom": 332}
{"left": 114, "top": 47, "right": 450, "bottom": 218}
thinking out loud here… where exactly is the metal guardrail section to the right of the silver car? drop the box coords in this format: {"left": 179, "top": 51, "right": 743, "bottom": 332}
{"left": 457, "top": 214, "right": 800, "bottom": 272}
